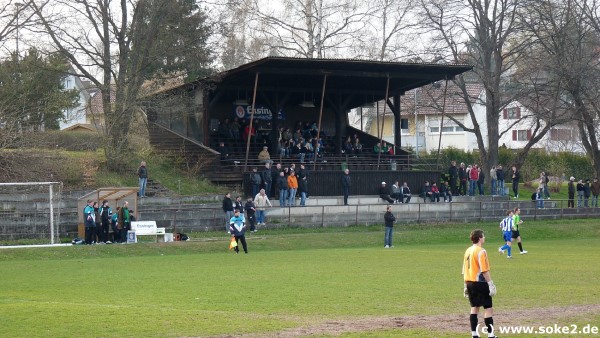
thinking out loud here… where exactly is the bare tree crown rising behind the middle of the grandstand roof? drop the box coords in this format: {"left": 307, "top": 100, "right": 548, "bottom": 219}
{"left": 249, "top": 0, "right": 367, "bottom": 58}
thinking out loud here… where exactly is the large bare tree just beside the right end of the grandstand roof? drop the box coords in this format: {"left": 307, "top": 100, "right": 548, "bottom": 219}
{"left": 420, "top": 0, "right": 560, "bottom": 171}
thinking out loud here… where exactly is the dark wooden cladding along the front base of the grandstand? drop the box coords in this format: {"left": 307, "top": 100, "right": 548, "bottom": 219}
{"left": 244, "top": 170, "right": 442, "bottom": 198}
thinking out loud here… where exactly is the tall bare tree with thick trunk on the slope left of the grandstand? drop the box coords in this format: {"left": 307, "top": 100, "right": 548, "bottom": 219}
{"left": 31, "top": 0, "right": 209, "bottom": 169}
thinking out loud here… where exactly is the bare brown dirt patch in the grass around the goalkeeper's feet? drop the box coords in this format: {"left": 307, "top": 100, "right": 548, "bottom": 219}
{"left": 213, "top": 304, "right": 600, "bottom": 338}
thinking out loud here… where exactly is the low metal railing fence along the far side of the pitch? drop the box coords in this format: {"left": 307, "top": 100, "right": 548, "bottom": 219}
{"left": 130, "top": 199, "right": 600, "bottom": 232}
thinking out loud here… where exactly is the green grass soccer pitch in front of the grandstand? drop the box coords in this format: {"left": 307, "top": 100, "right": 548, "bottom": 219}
{"left": 0, "top": 219, "right": 600, "bottom": 337}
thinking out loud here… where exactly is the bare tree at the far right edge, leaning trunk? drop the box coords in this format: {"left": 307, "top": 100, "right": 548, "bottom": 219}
{"left": 523, "top": 0, "right": 600, "bottom": 175}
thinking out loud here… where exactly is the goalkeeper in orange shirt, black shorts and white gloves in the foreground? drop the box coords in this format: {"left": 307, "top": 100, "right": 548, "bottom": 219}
{"left": 462, "top": 229, "right": 496, "bottom": 338}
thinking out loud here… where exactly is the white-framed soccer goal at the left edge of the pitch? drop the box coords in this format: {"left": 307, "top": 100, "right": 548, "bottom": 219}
{"left": 0, "top": 182, "right": 62, "bottom": 245}
